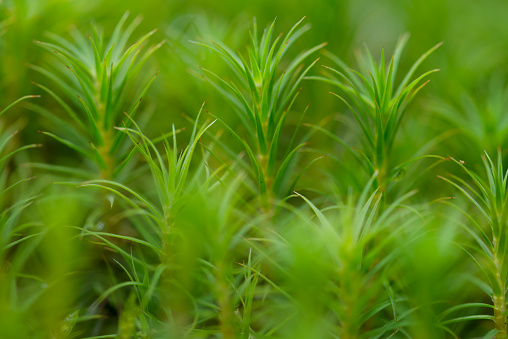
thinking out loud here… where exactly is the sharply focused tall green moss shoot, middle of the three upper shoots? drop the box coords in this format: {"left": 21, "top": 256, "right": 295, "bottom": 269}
{"left": 196, "top": 19, "right": 325, "bottom": 207}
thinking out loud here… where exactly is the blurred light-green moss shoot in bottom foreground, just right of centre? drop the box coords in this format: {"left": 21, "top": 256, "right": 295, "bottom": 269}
{"left": 270, "top": 177, "right": 419, "bottom": 338}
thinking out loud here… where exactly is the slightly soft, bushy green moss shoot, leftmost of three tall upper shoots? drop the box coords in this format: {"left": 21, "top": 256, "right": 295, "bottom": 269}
{"left": 30, "top": 14, "right": 164, "bottom": 179}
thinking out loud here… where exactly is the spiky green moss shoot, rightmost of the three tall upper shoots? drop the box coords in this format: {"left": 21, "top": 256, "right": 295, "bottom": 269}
{"left": 309, "top": 35, "right": 441, "bottom": 197}
